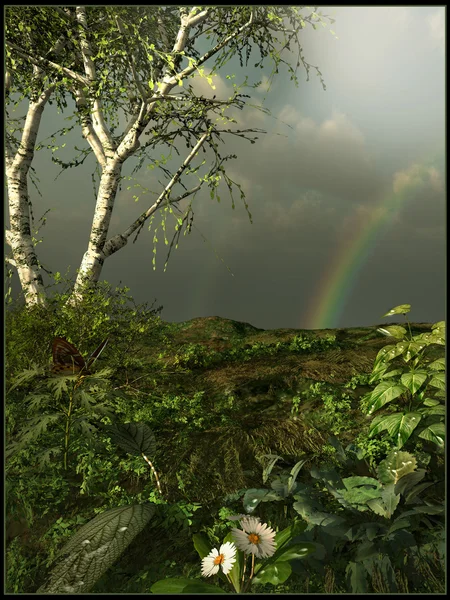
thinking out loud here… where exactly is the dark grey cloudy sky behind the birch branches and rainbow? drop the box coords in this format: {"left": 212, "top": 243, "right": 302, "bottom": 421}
{"left": 8, "top": 6, "right": 446, "bottom": 329}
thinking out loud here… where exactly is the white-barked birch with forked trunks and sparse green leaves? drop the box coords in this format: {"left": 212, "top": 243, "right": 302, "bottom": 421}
{"left": 5, "top": 6, "right": 332, "bottom": 305}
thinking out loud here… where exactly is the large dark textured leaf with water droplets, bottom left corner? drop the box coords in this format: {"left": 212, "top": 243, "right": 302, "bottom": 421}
{"left": 38, "top": 504, "right": 155, "bottom": 594}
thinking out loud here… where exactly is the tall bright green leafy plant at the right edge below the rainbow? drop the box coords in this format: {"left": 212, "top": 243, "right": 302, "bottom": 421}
{"left": 362, "top": 304, "right": 445, "bottom": 451}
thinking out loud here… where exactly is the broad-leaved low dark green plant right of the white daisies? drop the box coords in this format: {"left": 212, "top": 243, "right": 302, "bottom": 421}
{"left": 239, "top": 438, "right": 444, "bottom": 593}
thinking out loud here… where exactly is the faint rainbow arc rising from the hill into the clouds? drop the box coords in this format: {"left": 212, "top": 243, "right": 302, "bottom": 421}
{"left": 302, "top": 164, "right": 442, "bottom": 329}
